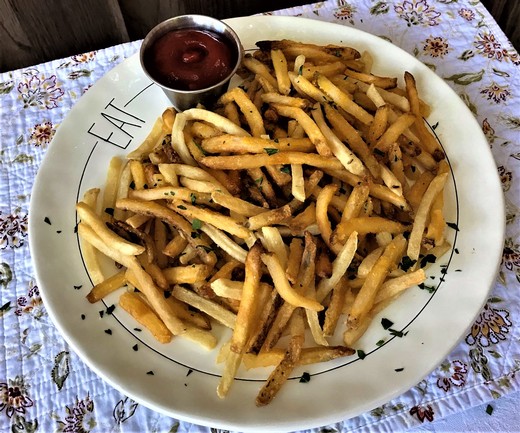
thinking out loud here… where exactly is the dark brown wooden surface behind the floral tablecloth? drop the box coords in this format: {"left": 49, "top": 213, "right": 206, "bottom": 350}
{"left": 0, "top": 0, "right": 520, "bottom": 72}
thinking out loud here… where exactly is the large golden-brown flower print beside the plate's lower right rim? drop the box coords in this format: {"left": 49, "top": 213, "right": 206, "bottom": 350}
{"left": 466, "top": 304, "right": 512, "bottom": 347}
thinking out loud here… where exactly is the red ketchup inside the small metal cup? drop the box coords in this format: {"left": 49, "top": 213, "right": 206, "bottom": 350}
{"left": 144, "top": 29, "right": 237, "bottom": 90}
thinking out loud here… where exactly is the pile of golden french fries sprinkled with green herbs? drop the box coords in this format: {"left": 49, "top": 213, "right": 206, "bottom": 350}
{"left": 76, "top": 40, "right": 449, "bottom": 406}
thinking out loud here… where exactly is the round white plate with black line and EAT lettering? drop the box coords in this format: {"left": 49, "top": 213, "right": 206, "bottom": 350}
{"left": 29, "top": 16, "right": 504, "bottom": 431}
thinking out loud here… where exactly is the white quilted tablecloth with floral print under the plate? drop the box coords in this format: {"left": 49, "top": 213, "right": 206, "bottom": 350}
{"left": 0, "top": 0, "right": 520, "bottom": 432}
